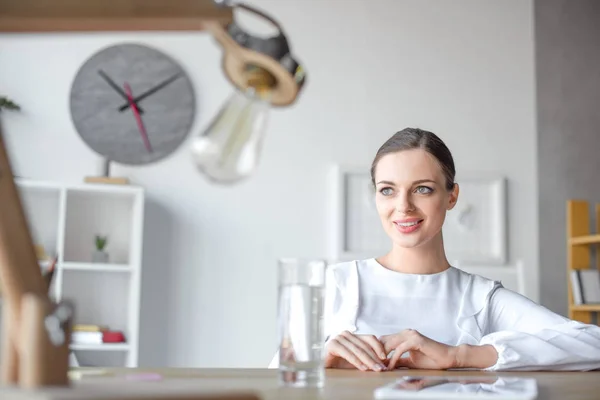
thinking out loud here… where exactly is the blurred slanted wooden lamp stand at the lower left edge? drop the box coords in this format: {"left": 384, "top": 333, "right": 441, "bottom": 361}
{"left": 0, "top": 122, "right": 72, "bottom": 388}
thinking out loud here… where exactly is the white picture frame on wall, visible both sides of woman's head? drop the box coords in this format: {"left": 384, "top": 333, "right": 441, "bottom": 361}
{"left": 331, "top": 165, "right": 508, "bottom": 266}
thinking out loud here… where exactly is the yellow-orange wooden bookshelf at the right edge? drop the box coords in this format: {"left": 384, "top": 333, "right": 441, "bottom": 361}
{"left": 567, "top": 200, "right": 600, "bottom": 324}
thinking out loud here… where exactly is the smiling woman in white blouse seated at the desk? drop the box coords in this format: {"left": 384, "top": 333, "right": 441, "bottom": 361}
{"left": 271, "top": 128, "right": 600, "bottom": 371}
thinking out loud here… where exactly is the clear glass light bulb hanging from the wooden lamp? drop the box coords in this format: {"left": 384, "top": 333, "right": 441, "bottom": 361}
{"left": 192, "top": 81, "right": 271, "bottom": 183}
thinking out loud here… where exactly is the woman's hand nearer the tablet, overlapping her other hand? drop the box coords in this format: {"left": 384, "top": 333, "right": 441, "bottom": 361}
{"left": 380, "top": 329, "right": 459, "bottom": 370}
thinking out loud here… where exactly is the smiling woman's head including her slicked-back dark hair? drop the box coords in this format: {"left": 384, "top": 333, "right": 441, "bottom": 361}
{"left": 371, "top": 130, "right": 458, "bottom": 260}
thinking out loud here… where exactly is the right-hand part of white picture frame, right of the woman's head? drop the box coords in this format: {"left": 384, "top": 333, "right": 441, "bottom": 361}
{"left": 442, "top": 175, "right": 508, "bottom": 265}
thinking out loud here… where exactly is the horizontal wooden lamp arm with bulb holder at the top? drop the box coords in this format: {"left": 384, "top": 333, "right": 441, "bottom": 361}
{"left": 0, "top": 0, "right": 306, "bottom": 106}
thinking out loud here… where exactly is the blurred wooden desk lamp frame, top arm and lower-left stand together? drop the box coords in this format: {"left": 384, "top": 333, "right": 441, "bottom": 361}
{"left": 0, "top": 0, "right": 305, "bottom": 399}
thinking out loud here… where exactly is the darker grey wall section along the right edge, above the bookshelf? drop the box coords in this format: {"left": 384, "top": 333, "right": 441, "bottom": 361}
{"left": 534, "top": 0, "right": 600, "bottom": 315}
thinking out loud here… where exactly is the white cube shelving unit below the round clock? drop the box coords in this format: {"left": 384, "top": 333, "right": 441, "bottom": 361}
{"left": 15, "top": 179, "right": 144, "bottom": 367}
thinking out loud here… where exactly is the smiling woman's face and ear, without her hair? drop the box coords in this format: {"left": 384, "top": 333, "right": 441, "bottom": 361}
{"left": 375, "top": 149, "right": 458, "bottom": 247}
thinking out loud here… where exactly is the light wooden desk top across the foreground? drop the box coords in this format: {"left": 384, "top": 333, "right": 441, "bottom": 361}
{"left": 0, "top": 368, "right": 600, "bottom": 400}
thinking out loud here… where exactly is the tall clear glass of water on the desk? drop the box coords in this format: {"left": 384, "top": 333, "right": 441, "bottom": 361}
{"left": 278, "top": 258, "right": 327, "bottom": 387}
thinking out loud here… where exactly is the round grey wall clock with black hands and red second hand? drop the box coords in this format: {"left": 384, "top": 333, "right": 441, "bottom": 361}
{"left": 70, "top": 43, "right": 196, "bottom": 165}
